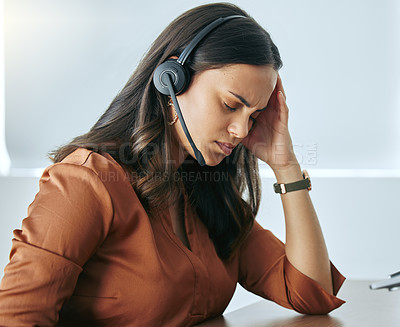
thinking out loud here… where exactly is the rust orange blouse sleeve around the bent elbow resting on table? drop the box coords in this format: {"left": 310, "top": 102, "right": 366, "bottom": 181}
{"left": 239, "top": 222, "right": 345, "bottom": 314}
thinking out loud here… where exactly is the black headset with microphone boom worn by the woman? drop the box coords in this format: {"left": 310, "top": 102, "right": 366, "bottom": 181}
{"left": 153, "top": 15, "right": 246, "bottom": 166}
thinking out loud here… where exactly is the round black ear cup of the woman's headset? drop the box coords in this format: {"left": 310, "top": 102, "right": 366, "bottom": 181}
{"left": 153, "top": 59, "right": 190, "bottom": 95}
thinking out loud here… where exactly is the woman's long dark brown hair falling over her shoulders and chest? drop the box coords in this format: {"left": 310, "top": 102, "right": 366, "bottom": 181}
{"left": 49, "top": 3, "right": 282, "bottom": 260}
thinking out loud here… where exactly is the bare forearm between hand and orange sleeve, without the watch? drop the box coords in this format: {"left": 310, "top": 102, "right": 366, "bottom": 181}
{"left": 274, "top": 164, "right": 332, "bottom": 294}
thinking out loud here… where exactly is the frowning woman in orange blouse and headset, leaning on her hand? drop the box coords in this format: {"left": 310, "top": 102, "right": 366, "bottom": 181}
{"left": 0, "top": 4, "right": 344, "bottom": 326}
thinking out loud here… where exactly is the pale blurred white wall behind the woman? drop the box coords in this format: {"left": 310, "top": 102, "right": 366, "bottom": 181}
{"left": 0, "top": 0, "right": 400, "bottom": 316}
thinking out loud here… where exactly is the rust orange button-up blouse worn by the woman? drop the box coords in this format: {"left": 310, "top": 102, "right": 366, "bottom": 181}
{"left": 0, "top": 149, "right": 344, "bottom": 327}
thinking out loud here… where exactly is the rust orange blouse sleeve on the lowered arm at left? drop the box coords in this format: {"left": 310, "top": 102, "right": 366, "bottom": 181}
{"left": 0, "top": 163, "right": 113, "bottom": 326}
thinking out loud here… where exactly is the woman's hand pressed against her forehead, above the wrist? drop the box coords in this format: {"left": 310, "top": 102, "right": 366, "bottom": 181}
{"left": 242, "top": 74, "right": 298, "bottom": 171}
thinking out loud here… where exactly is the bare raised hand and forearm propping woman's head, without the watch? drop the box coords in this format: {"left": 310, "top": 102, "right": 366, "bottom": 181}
{"left": 242, "top": 75, "right": 333, "bottom": 295}
